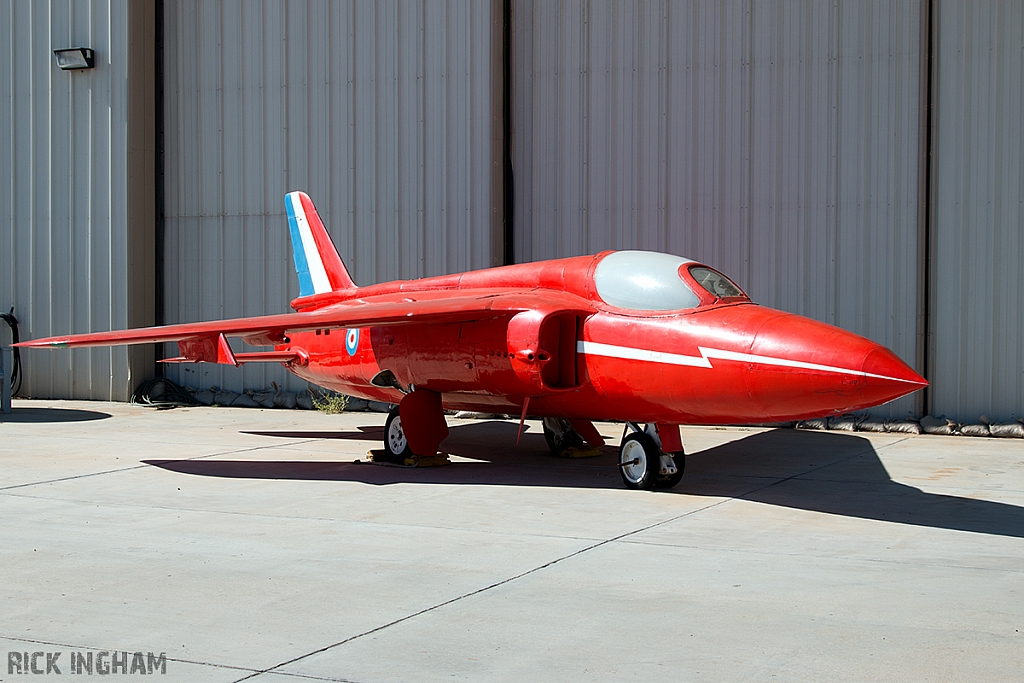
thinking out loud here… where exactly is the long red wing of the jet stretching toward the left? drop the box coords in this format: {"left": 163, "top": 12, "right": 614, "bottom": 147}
{"left": 15, "top": 288, "right": 594, "bottom": 361}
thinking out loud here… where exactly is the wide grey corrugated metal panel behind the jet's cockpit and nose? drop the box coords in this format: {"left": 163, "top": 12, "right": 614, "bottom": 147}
{"left": 512, "top": 0, "right": 922, "bottom": 416}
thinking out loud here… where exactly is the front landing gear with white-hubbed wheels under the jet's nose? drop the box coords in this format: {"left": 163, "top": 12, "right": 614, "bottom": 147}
{"left": 618, "top": 422, "right": 685, "bottom": 490}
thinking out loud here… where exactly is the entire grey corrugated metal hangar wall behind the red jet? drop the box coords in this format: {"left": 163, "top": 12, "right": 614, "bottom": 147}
{"left": 6, "top": 0, "right": 1024, "bottom": 420}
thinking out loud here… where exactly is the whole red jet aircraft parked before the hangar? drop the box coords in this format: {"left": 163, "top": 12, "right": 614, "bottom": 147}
{"left": 19, "top": 193, "right": 928, "bottom": 488}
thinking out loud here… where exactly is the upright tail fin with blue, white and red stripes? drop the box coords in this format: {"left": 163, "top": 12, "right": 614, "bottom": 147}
{"left": 285, "top": 193, "right": 355, "bottom": 297}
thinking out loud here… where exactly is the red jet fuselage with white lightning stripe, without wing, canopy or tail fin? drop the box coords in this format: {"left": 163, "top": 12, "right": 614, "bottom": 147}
{"left": 278, "top": 255, "right": 921, "bottom": 424}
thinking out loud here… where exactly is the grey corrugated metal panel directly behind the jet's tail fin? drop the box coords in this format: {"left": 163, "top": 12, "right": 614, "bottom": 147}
{"left": 164, "top": 0, "right": 503, "bottom": 390}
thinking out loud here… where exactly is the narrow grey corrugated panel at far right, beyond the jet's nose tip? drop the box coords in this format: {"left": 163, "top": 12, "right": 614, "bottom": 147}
{"left": 931, "top": 0, "right": 1024, "bottom": 421}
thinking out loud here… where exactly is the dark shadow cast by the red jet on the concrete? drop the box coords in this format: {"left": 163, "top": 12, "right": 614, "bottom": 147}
{"left": 143, "top": 422, "right": 1024, "bottom": 538}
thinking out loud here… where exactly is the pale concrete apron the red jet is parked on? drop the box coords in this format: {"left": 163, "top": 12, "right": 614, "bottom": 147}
{"left": 0, "top": 399, "right": 1024, "bottom": 683}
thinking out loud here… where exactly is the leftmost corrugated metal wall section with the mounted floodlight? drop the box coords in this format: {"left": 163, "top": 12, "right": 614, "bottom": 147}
{"left": 0, "top": 0, "right": 154, "bottom": 400}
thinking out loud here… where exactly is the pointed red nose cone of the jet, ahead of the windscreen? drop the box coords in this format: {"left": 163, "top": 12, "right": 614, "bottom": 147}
{"left": 750, "top": 314, "right": 928, "bottom": 422}
